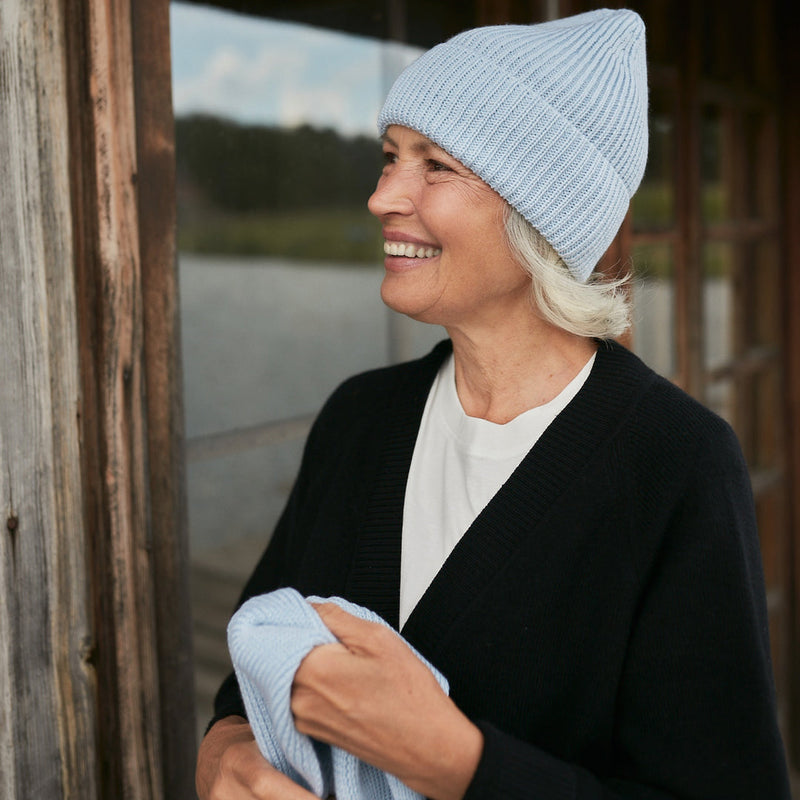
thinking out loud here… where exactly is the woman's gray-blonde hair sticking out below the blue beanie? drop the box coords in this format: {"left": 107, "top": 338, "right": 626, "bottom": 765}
{"left": 505, "top": 206, "right": 631, "bottom": 339}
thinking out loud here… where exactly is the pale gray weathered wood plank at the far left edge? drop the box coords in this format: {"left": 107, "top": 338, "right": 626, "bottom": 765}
{"left": 0, "top": 0, "right": 97, "bottom": 800}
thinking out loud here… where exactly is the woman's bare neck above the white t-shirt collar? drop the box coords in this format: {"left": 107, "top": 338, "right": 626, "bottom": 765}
{"left": 448, "top": 319, "right": 597, "bottom": 424}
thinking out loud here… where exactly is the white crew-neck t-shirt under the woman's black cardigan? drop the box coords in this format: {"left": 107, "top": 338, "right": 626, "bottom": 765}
{"left": 400, "top": 356, "right": 595, "bottom": 626}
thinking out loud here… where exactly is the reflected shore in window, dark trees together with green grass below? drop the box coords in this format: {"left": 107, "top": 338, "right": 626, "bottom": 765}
{"left": 176, "top": 116, "right": 381, "bottom": 264}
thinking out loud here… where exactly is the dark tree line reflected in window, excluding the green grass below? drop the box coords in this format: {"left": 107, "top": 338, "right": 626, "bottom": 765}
{"left": 176, "top": 115, "right": 380, "bottom": 217}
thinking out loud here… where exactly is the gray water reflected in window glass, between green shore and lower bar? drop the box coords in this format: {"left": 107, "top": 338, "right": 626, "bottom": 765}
{"left": 180, "top": 253, "right": 387, "bottom": 437}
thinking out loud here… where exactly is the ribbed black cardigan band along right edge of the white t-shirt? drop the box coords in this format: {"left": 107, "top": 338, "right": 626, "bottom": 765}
{"left": 402, "top": 344, "right": 654, "bottom": 663}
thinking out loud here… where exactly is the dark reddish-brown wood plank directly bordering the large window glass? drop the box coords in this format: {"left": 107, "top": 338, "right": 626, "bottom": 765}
{"left": 131, "top": 0, "right": 196, "bottom": 800}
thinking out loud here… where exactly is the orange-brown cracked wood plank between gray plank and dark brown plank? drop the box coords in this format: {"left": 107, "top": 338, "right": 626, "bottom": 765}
{"left": 65, "top": 0, "right": 169, "bottom": 800}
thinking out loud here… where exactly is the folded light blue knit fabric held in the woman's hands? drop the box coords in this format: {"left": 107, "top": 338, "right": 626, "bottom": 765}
{"left": 228, "top": 589, "right": 449, "bottom": 800}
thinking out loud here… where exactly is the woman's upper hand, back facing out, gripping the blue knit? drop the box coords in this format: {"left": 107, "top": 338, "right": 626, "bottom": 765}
{"left": 292, "top": 603, "right": 483, "bottom": 800}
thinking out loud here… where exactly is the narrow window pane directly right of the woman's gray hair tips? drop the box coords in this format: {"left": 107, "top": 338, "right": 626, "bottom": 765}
{"left": 632, "top": 243, "right": 676, "bottom": 377}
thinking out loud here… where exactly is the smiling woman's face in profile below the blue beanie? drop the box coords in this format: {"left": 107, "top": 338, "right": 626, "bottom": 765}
{"left": 368, "top": 125, "right": 530, "bottom": 328}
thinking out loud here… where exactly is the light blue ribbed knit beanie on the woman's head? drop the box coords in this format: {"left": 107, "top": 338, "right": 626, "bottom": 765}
{"left": 378, "top": 9, "right": 647, "bottom": 282}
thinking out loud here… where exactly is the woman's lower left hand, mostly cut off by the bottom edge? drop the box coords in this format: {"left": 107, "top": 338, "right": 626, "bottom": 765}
{"left": 195, "top": 717, "right": 317, "bottom": 800}
